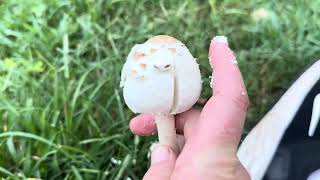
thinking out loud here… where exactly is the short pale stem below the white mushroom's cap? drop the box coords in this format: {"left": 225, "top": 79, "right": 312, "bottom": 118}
{"left": 155, "top": 114, "right": 180, "bottom": 154}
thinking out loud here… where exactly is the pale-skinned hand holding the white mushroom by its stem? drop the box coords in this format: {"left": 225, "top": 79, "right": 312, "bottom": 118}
{"left": 130, "top": 38, "right": 250, "bottom": 180}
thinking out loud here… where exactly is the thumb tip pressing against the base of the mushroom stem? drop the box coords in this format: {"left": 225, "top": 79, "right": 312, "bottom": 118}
{"left": 143, "top": 145, "right": 177, "bottom": 180}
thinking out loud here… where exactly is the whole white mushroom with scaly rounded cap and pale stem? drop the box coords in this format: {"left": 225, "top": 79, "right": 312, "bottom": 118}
{"left": 120, "top": 35, "right": 202, "bottom": 153}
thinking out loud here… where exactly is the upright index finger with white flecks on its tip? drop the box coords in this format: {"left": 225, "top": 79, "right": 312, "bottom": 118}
{"left": 200, "top": 36, "right": 249, "bottom": 147}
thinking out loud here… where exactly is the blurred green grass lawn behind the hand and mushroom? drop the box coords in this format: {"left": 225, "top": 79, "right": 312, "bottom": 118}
{"left": 0, "top": 0, "right": 320, "bottom": 180}
